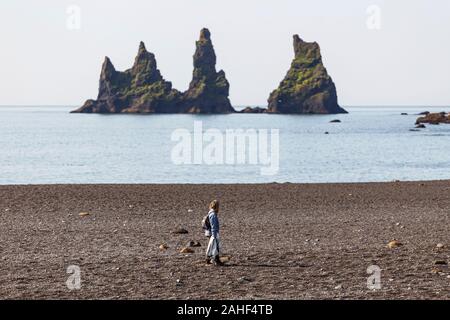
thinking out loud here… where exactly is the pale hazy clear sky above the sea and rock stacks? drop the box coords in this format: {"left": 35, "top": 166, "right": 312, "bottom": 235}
{"left": 0, "top": 0, "right": 450, "bottom": 106}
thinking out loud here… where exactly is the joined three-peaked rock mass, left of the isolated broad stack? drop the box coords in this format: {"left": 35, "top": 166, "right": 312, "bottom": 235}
{"left": 72, "top": 29, "right": 235, "bottom": 113}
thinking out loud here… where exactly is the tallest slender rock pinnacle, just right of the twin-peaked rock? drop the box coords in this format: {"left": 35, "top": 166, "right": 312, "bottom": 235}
{"left": 183, "top": 28, "right": 235, "bottom": 113}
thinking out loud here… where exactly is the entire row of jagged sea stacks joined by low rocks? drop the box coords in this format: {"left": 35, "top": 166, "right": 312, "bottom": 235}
{"left": 72, "top": 28, "right": 347, "bottom": 114}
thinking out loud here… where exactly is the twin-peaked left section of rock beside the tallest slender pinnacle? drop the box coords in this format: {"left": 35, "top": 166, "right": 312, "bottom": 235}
{"left": 72, "top": 42, "right": 181, "bottom": 113}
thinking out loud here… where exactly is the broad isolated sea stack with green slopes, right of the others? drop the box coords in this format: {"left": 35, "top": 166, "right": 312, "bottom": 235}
{"left": 268, "top": 35, "right": 347, "bottom": 114}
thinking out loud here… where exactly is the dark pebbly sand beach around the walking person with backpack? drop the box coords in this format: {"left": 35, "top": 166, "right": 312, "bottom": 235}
{"left": 0, "top": 181, "right": 450, "bottom": 299}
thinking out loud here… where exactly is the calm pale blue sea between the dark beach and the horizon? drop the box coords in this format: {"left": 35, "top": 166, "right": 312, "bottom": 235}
{"left": 0, "top": 106, "right": 450, "bottom": 184}
